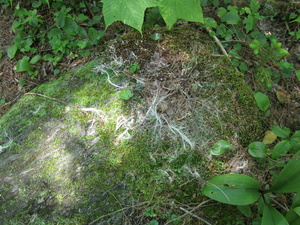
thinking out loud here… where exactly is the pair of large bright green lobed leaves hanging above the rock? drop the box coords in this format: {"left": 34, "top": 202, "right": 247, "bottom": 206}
{"left": 102, "top": 0, "right": 203, "bottom": 33}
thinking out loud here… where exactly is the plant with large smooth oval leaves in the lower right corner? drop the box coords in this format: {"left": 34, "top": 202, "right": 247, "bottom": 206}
{"left": 202, "top": 151, "right": 300, "bottom": 225}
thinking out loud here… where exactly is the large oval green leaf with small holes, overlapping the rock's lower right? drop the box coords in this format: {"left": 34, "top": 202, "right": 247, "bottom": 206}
{"left": 202, "top": 174, "right": 260, "bottom": 205}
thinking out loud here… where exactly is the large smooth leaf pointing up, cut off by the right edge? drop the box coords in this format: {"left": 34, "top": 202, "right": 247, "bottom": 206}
{"left": 269, "top": 151, "right": 300, "bottom": 193}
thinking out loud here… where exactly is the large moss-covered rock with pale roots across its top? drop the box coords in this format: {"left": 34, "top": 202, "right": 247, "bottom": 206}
{"left": 0, "top": 25, "right": 262, "bottom": 224}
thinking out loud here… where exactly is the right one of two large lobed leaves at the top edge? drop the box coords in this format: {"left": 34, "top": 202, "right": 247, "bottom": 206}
{"left": 159, "top": 0, "right": 203, "bottom": 29}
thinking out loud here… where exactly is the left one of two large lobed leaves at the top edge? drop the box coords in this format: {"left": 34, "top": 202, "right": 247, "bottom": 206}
{"left": 102, "top": 0, "right": 157, "bottom": 33}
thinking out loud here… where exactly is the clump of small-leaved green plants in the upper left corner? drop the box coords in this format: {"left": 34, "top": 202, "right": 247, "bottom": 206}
{"left": 7, "top": 0, "right": 104, "bottom": 78}
